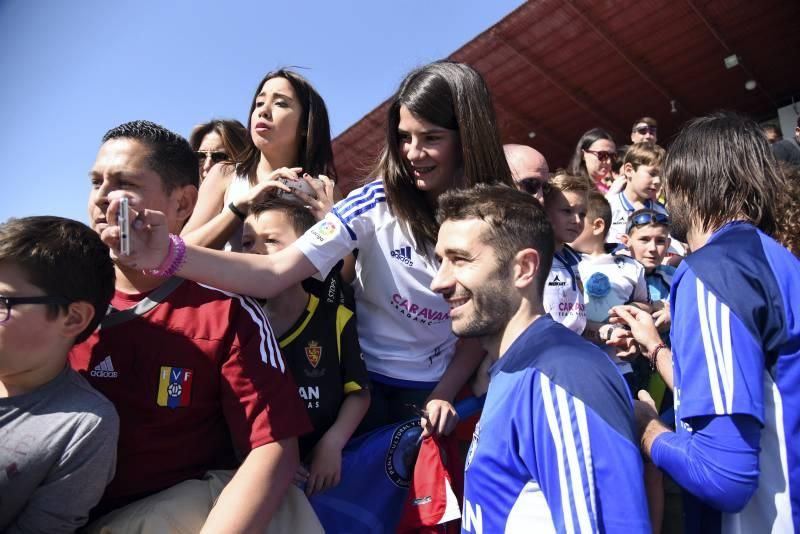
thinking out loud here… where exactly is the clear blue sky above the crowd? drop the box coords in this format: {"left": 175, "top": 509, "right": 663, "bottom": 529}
{"left": 0, "top": 0, "right": 522, "bottom": 222}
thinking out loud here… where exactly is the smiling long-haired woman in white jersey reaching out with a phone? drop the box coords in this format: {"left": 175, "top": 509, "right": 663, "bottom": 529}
{"left": 104, "top": 61, "right": 513, "bottom": 440}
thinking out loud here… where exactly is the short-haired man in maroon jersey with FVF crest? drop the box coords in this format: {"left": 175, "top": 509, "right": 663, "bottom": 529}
{"left": 70, "top": 121, "right": 320, "bottom": 532}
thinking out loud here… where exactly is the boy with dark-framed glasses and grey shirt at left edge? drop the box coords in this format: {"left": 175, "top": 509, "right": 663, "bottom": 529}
{"left": 0, "top": 217, "right": 119, "bottom": 534}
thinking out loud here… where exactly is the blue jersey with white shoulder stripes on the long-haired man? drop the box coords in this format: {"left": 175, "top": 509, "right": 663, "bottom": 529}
{"left": 671, "top": 223, "right": 800, "bottom": 533}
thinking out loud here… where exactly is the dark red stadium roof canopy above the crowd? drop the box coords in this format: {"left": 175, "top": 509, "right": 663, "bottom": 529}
{"left": 333, "top": 0, "right": 800, "bottom": 191}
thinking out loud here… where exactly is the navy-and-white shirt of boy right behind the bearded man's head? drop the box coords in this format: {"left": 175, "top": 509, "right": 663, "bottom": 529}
{"left": 542, "top": 245, "right": 586, "bottom": 334}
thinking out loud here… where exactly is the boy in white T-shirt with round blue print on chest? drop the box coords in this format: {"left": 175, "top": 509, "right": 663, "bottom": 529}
{"left": 572, "top": 191, "right": 650, "bottom": 386}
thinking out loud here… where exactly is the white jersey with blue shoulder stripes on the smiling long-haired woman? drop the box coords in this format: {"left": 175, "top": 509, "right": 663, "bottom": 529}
{"left": 295, "top": 180, "right": 457, "bottom": 382}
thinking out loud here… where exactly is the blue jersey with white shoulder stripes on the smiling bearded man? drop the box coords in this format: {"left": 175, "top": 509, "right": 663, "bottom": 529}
{"left": 461, "top": 315, "right": 650, "bottom": 534}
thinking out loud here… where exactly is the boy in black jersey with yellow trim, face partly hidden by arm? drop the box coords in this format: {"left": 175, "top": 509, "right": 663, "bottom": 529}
{"left": 242, "top": 198, "right": 370, "bottom": 495}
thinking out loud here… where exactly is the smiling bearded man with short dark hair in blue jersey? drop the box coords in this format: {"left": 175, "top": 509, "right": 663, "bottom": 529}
{"left": 431, "top": 186, "right": 650, "bottom": 534}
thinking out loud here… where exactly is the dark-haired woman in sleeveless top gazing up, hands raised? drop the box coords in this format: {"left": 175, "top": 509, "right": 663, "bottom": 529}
{"left": 181, "top": 69, "right": 336, "bottom": 251}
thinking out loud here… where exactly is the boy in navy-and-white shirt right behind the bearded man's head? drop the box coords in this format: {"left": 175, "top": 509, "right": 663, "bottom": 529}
{"left": 542, "top": 172, "right": 589, "bottom": 335}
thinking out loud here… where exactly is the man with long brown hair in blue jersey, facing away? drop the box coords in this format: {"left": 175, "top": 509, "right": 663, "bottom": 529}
{"left": 626, "top": 113, "right": 800, "bottom": 534}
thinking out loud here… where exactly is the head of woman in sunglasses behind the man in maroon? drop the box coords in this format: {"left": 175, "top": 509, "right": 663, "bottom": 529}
{"left": 189, "top": 119, "right": 247, "bottom": 183}
